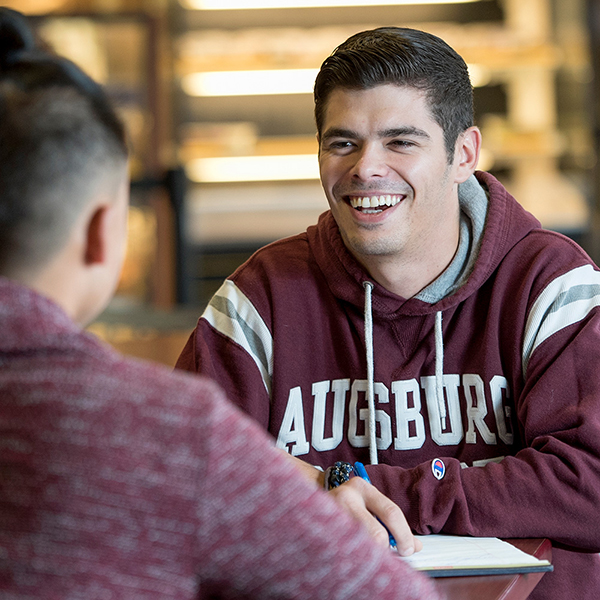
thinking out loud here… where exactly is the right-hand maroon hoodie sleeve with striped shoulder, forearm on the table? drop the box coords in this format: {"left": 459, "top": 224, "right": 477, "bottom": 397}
{"left": 369, "top": 264, "right": 600, "bottom": 552}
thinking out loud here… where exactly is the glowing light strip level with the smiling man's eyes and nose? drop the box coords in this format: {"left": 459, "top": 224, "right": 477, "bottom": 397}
{"left": 186, "top": 154, "right": 319, "bottom": 183}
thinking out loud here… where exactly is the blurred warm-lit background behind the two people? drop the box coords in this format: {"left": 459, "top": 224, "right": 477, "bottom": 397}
{"left": 8, "top": 0, "right": 600, "bottom": 365}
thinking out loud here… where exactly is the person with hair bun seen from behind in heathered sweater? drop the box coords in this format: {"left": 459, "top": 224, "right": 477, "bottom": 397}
{"left": 0, "top": 8, "right": 439, "bottom": 600}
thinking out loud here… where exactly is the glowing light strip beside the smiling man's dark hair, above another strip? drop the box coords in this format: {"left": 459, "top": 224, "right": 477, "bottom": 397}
{"left": 181, "top": 69, "right": 318, "bottom": 96}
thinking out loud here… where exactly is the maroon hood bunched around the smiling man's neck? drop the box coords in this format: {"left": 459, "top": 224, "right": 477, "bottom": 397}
{"left": 307, "top": 171, "right": 541, "bottom": 319}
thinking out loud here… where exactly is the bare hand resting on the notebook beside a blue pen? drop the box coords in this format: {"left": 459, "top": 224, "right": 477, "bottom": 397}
{"left": 328, "top": 477, "right": 423, "bottom": 556}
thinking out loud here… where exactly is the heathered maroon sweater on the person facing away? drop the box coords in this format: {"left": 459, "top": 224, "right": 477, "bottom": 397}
{"left": 0, "top": 278, "right": 438, "bottom": 600}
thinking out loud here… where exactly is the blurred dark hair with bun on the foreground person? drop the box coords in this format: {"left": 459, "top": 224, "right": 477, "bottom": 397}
{"left": 0, "top": 8, "right": 128, "bottom": 274}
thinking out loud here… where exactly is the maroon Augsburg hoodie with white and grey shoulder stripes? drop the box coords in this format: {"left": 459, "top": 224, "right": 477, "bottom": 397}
{"left": 178, "top": 173, "right": 600, "bottom": 600}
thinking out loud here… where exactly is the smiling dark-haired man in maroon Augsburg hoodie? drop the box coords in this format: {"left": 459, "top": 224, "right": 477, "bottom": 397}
{"left": 178, "top": 27, "right": 600, "bottom": 600}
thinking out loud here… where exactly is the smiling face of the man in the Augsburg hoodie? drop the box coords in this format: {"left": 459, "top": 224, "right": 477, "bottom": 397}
{"left": 319, "top": 84, "right": 458, "bottom": 276}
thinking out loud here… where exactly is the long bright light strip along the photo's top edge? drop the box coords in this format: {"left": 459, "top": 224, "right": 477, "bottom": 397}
{"left": 180, "top": 0, "right": 478, "bottom": 10}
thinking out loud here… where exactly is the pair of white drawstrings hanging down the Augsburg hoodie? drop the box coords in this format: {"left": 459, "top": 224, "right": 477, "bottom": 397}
{"left": 363, "top": 281, "right": 447, "bottom": 465}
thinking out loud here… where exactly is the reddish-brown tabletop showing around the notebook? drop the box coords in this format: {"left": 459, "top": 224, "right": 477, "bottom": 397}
{"left": 434, "top": 539, "right": 552, "bottom": 600}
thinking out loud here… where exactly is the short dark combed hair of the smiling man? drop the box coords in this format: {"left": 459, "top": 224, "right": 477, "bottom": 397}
{"left": 314, "top": 27, "right": 473, "bottom": 161}
